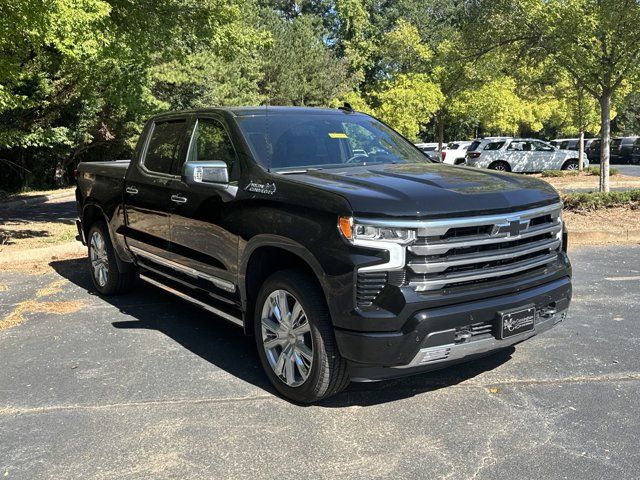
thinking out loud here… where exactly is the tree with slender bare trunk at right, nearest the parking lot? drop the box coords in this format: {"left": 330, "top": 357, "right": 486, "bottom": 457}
{"left": 476, "top": 0, "right": 640, "bottom": 192}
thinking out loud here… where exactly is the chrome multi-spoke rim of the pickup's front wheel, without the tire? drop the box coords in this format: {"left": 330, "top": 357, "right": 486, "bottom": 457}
{"left": 261, "top": 290, "right": 313, "bottom": 387}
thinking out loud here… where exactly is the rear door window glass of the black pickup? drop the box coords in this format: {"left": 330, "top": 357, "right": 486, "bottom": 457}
{"left": 143, "top": 119, "right": 186, "bottom": 174}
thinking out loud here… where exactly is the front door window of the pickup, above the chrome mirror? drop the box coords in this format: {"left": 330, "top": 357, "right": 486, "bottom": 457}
{"left": 188, "top": 118, "right": 239, "bottom": 180}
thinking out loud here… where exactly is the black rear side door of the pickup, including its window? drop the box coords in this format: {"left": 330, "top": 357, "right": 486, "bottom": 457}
{"left": 125, "top": 118, "right": 187, "bottom": 258}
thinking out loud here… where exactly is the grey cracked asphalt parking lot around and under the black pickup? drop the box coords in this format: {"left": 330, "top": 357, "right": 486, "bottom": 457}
{"left": 0, "top": 245, "right": 640, "bottom": 479}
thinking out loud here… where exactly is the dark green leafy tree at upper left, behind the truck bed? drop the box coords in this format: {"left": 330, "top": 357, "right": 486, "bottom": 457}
{"left": 0, "top": 0, "right": 256, "bottom": 189}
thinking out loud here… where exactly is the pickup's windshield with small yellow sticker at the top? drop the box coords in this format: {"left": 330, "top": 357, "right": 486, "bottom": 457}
{"left": 237, "top": 112, "right": 431, "bottom": 171}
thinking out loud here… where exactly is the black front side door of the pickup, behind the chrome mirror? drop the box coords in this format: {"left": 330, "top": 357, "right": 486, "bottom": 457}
{"left": 165, "top": 114, "right": 240, "bottom": 295}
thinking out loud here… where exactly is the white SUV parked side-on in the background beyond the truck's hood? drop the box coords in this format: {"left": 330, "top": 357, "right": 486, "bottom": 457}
{"left": 466, "top": 137, "right": 589, "bottom": 172}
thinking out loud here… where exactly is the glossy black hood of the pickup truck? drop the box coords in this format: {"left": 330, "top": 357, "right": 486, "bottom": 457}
{"left": 286, "top": 164, "right": 558, "bottom": 218}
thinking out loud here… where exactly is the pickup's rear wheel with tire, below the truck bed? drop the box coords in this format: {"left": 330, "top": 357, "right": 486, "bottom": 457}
{"left": 87, "top": 220, "right": 137, "bottom": 296}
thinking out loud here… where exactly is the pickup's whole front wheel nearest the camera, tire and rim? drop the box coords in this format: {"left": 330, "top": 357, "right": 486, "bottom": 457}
{"left": 254, "top": 270, "right": 349, "bottom": 403}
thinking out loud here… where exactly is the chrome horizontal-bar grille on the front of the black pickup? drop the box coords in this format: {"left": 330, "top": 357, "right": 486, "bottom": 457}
{"left": 406, "top": 204, "right": 562, "bottom": 292}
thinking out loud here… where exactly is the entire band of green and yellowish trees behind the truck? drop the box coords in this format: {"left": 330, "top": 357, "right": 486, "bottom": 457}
{"left": 0, "top": 0, "right": 640, "bottom": 191}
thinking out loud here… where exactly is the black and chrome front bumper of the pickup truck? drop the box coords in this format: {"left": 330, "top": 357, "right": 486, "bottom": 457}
{"left": 336, "top": 277, "right": 571, "bottom": 381}
